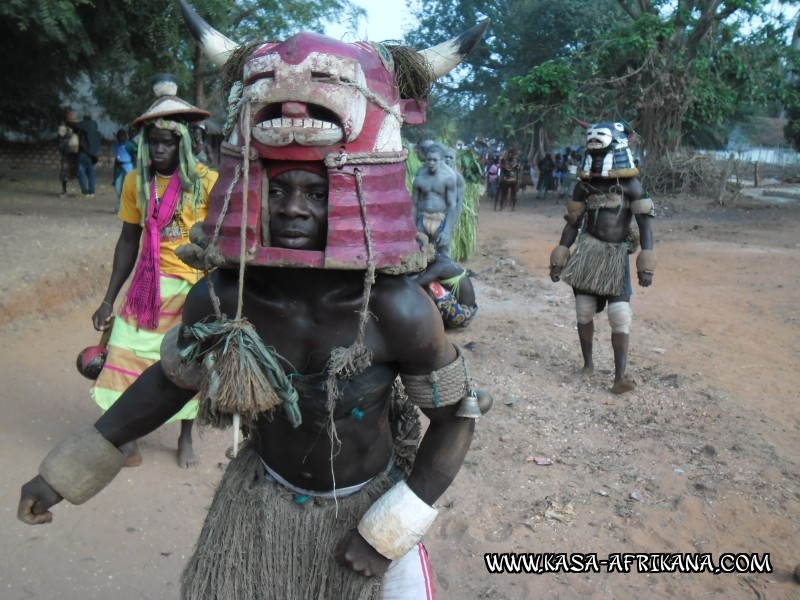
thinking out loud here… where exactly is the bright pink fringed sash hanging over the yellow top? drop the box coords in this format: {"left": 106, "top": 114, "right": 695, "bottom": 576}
{"left": 122, "top": 169, "right": 182, "bottom": 330}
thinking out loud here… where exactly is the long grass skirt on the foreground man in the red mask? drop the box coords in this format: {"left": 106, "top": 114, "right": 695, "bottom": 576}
{"left": 181, "top": 445, "right": 393, "bottom": 600}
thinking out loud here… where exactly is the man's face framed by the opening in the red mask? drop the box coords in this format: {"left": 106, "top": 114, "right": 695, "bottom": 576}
{"left": 269, "top": 171, "right": 328, "bottom": 250}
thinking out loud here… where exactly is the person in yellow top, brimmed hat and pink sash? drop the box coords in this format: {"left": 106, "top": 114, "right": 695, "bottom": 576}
{"left": 91, "top": 75, "right": 218, "bottom": 468}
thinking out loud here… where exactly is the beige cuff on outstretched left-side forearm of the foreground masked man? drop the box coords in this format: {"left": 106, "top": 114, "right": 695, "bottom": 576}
{"left": 39, "top": 427, "right": 125, "bottom": 504}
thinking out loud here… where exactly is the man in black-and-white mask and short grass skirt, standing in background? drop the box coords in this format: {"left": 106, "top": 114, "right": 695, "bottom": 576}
{"left": 550, "top": 123, "right": 656, "bottom": 394}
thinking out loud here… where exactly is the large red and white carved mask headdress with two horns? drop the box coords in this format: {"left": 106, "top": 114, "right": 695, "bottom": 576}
{"left": 178, "top": 0, "right": 488, "bottom": 272}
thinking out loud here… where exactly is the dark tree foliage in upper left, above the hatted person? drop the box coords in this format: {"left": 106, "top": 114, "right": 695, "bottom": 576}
{"left": 0, "top": 0, "right": 364, "bottom": 139}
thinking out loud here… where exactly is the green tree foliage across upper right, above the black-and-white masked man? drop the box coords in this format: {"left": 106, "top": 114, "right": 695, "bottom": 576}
{"left": 415, "top": 0, "right": 800, "bottom": 168}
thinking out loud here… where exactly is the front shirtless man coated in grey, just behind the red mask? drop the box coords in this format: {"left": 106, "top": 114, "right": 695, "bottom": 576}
{"left": 412, "top": 144, "right": 458, "bottom": 256}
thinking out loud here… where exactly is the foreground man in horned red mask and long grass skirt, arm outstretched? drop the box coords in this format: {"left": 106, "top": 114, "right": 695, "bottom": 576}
{"left": 19, "top": 4, "right": 490, "bottom": 600}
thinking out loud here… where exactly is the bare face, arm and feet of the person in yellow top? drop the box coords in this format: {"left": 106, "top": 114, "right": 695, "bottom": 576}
{"left": 92, "top": 127, "right": 197, "bottom": 468}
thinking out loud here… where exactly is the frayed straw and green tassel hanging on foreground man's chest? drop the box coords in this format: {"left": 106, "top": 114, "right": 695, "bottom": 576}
{"left": 180, "top": 318, "right": 302, "bottom": 427}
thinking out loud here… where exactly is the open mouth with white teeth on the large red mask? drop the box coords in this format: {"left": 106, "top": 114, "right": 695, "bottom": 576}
{"left": 253, "top": 102, "right": 344, "bottom": 146}
